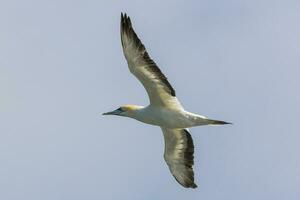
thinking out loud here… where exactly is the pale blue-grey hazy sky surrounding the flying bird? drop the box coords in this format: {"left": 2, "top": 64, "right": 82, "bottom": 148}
{"left": 0, "top": 0, "right": 300, "bottom": 200}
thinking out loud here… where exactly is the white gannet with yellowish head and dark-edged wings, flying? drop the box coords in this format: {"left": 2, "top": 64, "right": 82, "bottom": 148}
{"left": 103, "top": 13, "right": 231, "bottom": 188}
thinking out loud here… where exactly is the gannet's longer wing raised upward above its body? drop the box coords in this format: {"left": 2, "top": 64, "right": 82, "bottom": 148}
{"left": 121, "top": 14, "right": 180, "bottom": 107}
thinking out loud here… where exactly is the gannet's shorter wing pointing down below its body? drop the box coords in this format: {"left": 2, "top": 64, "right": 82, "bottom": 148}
{"left": 161, "top": 127, "right": 197, "bottom": 188}
